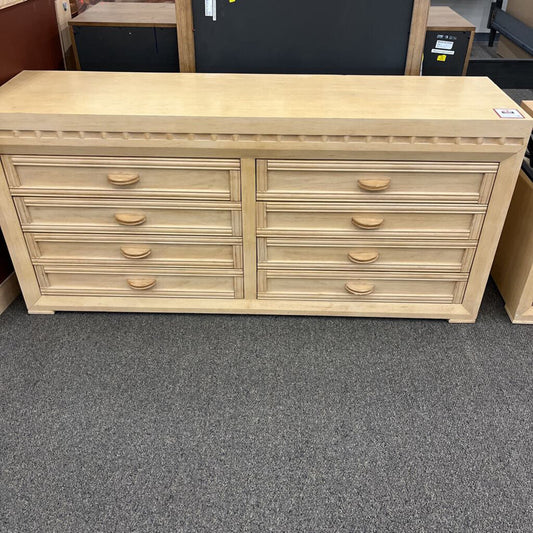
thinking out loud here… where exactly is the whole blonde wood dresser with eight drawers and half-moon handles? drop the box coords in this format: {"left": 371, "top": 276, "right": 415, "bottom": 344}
{"left": 0, "top": 72, "right": 533, "bottom": 322}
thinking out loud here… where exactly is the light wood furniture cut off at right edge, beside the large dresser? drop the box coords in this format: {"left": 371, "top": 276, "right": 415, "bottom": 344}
{"left": 492, "top": 101, "right": 533, "bottom": 324}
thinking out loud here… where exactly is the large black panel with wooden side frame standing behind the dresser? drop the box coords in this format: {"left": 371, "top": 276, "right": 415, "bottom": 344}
{"left": 176, "top": 0, "right": 430, "bottom": 76}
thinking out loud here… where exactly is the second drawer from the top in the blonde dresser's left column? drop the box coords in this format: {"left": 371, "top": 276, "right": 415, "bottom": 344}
{"left": 14, "top": 197, "right": 241, "bottom": 236}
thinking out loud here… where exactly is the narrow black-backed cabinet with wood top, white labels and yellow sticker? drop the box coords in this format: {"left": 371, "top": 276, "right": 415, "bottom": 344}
{"left": 422, "top": 6, "right": 476, "bottom": 76}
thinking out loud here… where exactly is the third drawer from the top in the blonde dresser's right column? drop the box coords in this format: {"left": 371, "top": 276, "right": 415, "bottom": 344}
{"left": 257, "top": 238, "right": 476, "bottom": 272}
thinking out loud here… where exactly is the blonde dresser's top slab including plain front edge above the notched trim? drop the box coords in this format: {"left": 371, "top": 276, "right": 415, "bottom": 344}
{"left": 0, "top": 71, "right": 533, "bottom": 140}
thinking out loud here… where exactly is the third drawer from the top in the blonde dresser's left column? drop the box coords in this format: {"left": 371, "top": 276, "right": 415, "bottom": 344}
{"left": 25, "top": 233, "right": 242, "bottom": 269}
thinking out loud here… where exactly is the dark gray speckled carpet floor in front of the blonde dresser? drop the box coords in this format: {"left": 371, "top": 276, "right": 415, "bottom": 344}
{"left": 0, "top": 283, "right": 533, "bottom": 533}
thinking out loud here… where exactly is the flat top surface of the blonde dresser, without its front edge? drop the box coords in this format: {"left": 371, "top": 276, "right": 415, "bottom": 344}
{"left": 0, "top": 71, "right": 518, "bottom": 122}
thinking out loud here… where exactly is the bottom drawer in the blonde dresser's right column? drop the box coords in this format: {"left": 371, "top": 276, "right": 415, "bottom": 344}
{"left": 258, "top": 270, "right": 467, "bottom": 303}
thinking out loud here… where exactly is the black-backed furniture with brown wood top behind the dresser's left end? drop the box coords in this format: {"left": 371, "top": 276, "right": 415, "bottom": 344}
{"left": 69, "top": 2, "right": 179, "bottom": 72}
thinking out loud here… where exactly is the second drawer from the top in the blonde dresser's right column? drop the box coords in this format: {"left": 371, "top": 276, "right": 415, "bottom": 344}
{"left": 257, "top": 202, "right": 484, "bottom": 239}
